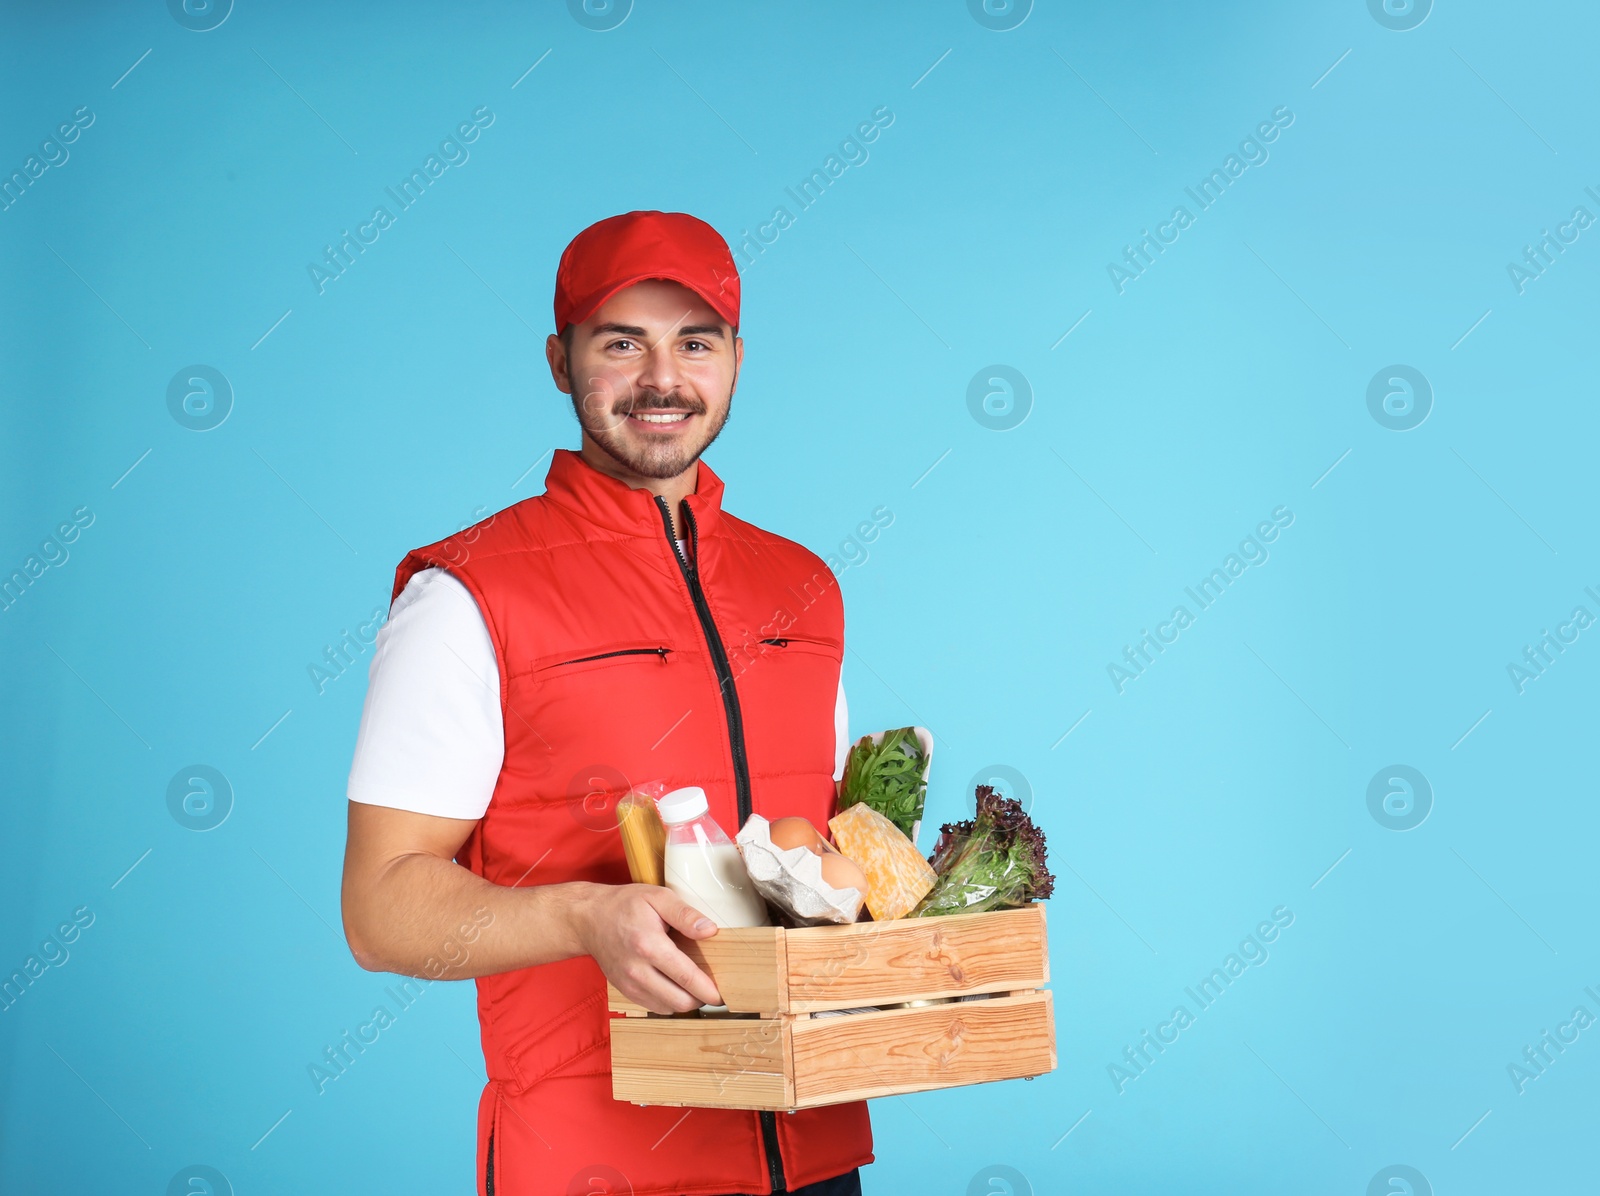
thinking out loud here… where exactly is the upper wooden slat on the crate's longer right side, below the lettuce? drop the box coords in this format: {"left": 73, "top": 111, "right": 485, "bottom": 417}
{"left": 777, "top": 903, "right": 1050, "bottom": 1012}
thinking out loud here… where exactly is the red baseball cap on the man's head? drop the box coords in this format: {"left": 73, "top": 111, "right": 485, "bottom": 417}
{"left": 555, "top": 211, "right": 739, "bottom": 331}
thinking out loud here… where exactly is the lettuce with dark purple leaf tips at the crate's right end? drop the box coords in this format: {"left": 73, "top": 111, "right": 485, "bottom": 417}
{"left": 907, "top": 785, "right": 1056, "bottom": 918}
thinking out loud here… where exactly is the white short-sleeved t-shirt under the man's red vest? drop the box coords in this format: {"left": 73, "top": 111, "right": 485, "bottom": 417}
{"left": 346, "top": 566, "right": 850, "bottom": 831}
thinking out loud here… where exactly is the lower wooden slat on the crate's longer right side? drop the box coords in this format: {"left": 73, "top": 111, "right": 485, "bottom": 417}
{"left": 790, "top": 991, "right": 1056, "bottom": 1108}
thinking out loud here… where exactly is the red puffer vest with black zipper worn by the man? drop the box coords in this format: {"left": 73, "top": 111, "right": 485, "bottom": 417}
{"left": 394, "top": 449, "right": 872, "bottom": 1196}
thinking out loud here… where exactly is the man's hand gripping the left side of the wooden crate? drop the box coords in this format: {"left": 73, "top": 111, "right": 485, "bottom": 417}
{"left": 571, "top": 884, "right": 722, "bottom": 1014}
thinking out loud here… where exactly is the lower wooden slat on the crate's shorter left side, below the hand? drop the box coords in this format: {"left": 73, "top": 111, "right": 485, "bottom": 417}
{"left": 611, "top": 1017, "right": 795, "bottom": 1110}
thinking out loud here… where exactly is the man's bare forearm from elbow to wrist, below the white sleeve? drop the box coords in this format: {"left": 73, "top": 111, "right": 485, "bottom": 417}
{"left": 344, "top": 852, "right": 594, "bottom": 980}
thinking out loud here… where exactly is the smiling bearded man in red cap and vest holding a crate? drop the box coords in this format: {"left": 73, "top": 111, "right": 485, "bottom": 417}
{"left": 342, "top": 211, "right": 872, "bottom": 1196}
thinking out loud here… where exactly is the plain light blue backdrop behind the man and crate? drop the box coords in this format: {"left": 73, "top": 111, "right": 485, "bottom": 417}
{"left": 0, "top": 0, "right": 1600, "bottom": 1196}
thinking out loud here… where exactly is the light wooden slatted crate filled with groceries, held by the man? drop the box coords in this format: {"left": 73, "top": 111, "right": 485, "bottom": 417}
{"left": 608, "top": 905, "right": 1056, "bottom": 1110}
